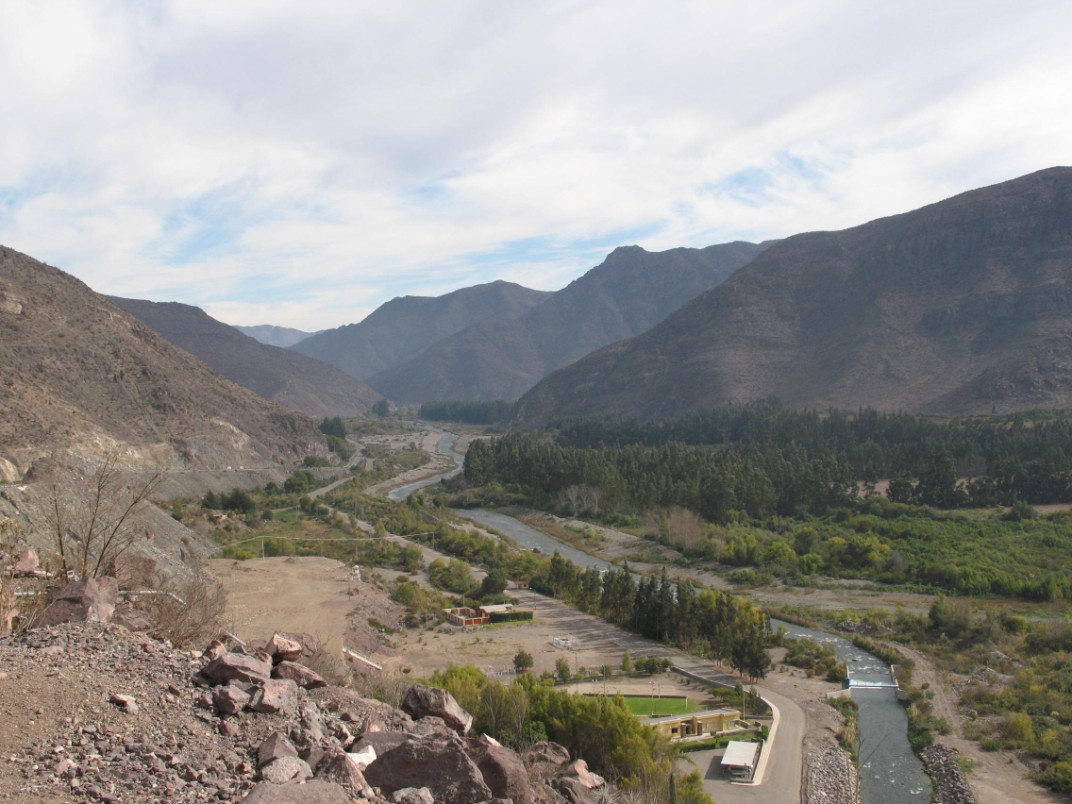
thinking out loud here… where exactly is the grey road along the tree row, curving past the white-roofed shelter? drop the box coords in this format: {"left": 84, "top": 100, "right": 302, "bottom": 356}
{"left": 510, "top": 590, "right": 804, "bottom": 804}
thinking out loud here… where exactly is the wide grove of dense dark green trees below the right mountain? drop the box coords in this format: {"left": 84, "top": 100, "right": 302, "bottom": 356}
{"left": 465, "top": 402, "right": 1072, "bottom": 521}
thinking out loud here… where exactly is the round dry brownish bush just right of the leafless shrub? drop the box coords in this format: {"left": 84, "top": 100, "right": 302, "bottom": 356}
{"left": 138, "top": 572, "right": 227, "bottom": 647}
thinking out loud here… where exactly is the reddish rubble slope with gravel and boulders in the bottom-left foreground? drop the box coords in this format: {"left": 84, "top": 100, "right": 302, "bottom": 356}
{"left": 0, "top": 623, "right": 607, "bottom": 804}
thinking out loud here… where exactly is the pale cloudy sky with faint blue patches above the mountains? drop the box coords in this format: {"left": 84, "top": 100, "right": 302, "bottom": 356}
{"left": 0, "top": 0, "right": 1072, "bottom": 331}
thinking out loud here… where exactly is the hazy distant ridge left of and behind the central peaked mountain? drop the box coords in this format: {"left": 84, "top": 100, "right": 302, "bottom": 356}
{"left": 293, "top": 281, "right": 550, "bottom": 379}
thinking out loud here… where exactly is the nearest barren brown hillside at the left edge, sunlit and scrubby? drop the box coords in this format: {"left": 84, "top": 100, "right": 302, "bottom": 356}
{"left": 0, "top": 247, "right": 323, "bottom": 479}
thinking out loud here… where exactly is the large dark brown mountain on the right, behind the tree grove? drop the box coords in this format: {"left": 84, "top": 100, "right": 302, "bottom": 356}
{"left": 520, "top": 167, "right": 1072, "bottom": 423}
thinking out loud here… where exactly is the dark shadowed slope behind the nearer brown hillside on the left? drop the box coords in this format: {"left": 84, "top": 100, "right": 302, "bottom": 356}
{"left": 111, "top": 298, "right": 381, "bottom": 418}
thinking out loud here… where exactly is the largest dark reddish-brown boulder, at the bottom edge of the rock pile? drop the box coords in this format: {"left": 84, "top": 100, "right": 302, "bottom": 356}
{"left": 364, "top": 740, "right": 492, "bottom": 804}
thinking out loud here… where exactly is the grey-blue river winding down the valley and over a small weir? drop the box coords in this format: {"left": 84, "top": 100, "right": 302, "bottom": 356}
{"left": 400, "top": 431, "right": 930, "bottom": 804}
